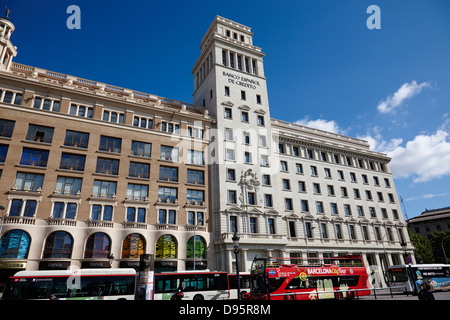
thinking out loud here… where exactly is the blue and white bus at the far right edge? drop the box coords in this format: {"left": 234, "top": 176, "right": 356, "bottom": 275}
{"left": 388, "top": 264, "right": 450, "bottom": 293}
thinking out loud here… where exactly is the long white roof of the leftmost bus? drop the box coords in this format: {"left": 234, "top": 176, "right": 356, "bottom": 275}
{"left": 14, "top": 268, "right": 136, "bottom": 277}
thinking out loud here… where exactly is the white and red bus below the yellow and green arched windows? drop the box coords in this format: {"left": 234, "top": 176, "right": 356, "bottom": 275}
{"left": 153, "top": 271, "right": 230, "bottom": 300}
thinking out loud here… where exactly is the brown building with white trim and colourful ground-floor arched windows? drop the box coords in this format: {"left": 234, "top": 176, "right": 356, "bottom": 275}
{"left": 0, "top": 15, "right": 214, "bottom": 286}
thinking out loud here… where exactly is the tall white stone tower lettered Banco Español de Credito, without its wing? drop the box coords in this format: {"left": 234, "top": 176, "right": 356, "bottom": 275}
{"left": 192, "top": 16, "right": 282, "bottom": 272}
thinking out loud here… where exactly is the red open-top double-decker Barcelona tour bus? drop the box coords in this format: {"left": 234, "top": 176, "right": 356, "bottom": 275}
{"left": 245, "top": 256, "right": 370, "bottom": 300}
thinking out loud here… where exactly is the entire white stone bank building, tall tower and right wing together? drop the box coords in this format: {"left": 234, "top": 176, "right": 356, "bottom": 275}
{"left": 192, "top": 16, "right": 412, "bottom": 286}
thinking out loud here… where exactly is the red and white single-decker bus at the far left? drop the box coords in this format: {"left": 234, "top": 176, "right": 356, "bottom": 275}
{"left": 2, "top": 269, "right": 136, "bottom": 300}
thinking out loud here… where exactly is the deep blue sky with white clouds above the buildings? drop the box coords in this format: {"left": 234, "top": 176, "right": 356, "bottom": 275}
{"left": 6, "top": 0, "right": 450, "bottom": 218}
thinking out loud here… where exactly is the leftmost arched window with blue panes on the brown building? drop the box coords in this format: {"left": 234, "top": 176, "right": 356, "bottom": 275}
{"left": 0, "top": 230, "right": 31, "bottom": 259}
